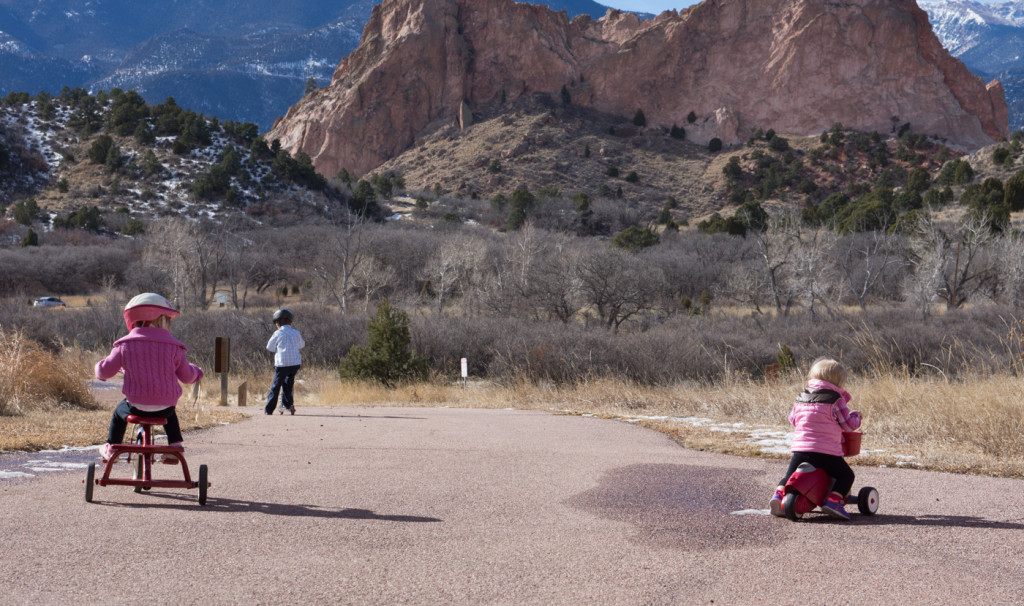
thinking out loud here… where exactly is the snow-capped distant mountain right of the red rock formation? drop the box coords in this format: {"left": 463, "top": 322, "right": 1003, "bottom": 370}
{"left": 919, "top": 0, "right": 1024, "bottom": 130}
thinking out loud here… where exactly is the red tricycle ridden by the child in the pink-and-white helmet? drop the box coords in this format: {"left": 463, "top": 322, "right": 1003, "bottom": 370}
{"left": 85, "top": 415, "right": 211, "bottom": 505}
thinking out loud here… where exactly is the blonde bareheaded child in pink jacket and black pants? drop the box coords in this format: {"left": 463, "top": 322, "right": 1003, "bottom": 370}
{"left": 769, "top": 358, "right": 860, "bottom": 520}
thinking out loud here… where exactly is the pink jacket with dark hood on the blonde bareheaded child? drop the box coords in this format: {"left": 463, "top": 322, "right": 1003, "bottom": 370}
{"left": 790, "top": 380, "right": 860, "bottom": 457}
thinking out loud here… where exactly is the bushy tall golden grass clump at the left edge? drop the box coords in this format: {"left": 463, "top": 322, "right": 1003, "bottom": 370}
{"left": 0, "top": 330, "right": 97, "bottom": 416}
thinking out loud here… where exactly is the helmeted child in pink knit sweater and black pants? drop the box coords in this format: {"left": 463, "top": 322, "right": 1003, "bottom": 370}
{"left": 96, "top": 293, "right": 203, "bottom": 464}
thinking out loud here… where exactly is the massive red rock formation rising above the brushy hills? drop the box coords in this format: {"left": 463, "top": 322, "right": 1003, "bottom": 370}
{"left": 268, "top": 0, "right": 1009, "bottom": 176}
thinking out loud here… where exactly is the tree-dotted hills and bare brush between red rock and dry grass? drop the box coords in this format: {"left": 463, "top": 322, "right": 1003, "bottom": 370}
{"left": 0, "top": 90, "right": 1024, "bottom": 384}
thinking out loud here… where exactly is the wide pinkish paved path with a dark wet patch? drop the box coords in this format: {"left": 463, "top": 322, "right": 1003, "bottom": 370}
{"left": 0, "top": 408, "right": 1024, "bottom": 605}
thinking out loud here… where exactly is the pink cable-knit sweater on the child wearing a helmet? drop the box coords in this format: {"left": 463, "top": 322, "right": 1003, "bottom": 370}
{"left": 96, "top": 327, "right": 203, "bottom": 410}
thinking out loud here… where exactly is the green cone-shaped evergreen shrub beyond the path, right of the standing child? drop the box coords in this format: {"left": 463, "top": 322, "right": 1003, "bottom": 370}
{"left": 339, "top": 299, "right": 428, "bottom": 387}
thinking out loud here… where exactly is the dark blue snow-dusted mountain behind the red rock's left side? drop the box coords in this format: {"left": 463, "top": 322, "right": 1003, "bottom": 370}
{"left": 0, "top": 0, "right": 606, "bottom": 130}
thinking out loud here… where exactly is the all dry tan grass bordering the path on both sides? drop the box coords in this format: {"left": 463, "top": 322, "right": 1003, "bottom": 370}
{"left": 0, "top": 335, "right": 1024, "bottom": 478}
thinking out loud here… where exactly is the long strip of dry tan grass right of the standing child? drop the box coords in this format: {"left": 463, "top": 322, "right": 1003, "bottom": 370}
{"left": 306, "top": 371, "right": 1024, "bottom": 478}
